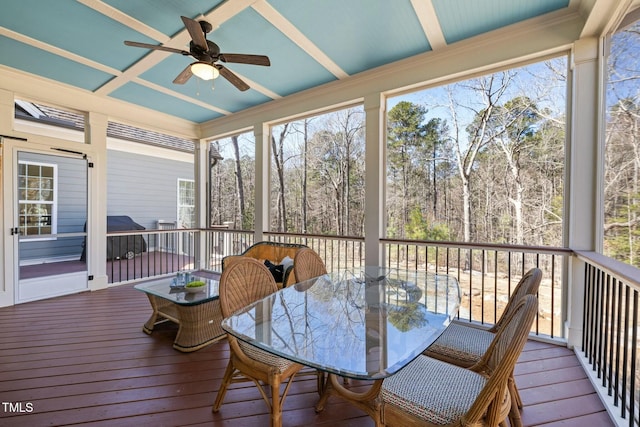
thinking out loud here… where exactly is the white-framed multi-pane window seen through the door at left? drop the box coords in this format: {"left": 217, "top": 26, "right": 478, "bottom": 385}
{"left": 18, "top": 162, "right": 58, "bottom": 236}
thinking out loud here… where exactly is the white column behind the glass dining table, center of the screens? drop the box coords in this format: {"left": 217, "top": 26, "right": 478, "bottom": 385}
{"left": 364, "top": 92, "right": 386, "bottom": 265}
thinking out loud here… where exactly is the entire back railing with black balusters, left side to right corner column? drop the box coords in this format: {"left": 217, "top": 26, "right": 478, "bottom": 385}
{"left": 107, "top": 228, "right": 571, "bottom": 338}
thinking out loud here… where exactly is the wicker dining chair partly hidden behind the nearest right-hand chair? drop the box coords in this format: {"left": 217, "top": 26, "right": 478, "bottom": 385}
{"left": 424, "top": 268, "right": 542, "bottom": 425}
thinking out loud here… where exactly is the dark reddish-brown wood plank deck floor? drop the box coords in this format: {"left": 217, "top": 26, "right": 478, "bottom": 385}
{"left": 0, "top": 285, "right": 613, "bottom": 427}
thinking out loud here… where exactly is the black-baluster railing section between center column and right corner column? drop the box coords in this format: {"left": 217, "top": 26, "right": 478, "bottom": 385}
{"left": 382, "top": 239, "right": 571, "bottom": 339}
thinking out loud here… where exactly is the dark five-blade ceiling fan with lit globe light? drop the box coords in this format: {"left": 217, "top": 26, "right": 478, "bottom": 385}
{"left": 124, "top": 16, "right": 271, "bottom": 91}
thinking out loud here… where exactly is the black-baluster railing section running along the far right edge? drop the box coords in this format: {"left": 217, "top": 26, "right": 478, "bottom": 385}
{"left": 576, "top": 251, "right": 640, "bottom": 427}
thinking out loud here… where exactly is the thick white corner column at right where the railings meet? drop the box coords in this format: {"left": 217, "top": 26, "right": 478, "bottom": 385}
{"left": 565, "top": 38, "right": 604, "bottom": 347}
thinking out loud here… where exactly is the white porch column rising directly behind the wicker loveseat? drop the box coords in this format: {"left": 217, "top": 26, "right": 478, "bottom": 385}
{"left": 253, "top": 123, "right": 271, "bottom": 242}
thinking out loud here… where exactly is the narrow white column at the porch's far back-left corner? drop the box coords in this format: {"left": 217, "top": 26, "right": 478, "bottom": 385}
{"left": 193, "top": 139, "right": 210, "bottom": 269}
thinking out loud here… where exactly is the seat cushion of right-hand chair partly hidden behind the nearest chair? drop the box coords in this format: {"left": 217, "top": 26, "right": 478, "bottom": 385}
{"left": 425, "top": 323, "right": 495, "bottom": 365}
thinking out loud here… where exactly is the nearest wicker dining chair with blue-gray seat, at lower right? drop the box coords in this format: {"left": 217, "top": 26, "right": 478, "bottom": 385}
{"left": 380, "top": 295, "right": 538, "bottom": 427}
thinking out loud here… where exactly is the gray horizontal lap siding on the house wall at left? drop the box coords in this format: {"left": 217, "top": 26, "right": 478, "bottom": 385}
{"left": 19, "top": 150, "right": 194, "bottom": 261}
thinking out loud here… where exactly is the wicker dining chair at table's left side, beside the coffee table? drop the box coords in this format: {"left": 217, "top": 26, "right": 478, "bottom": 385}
{"left": 213, "top": 257, "right": 302, "bottom": 426}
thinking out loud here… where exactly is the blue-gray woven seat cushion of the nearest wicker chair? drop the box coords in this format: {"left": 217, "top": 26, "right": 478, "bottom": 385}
{"left": 380, "top": 356, "right": 487, "bottom": 424}
